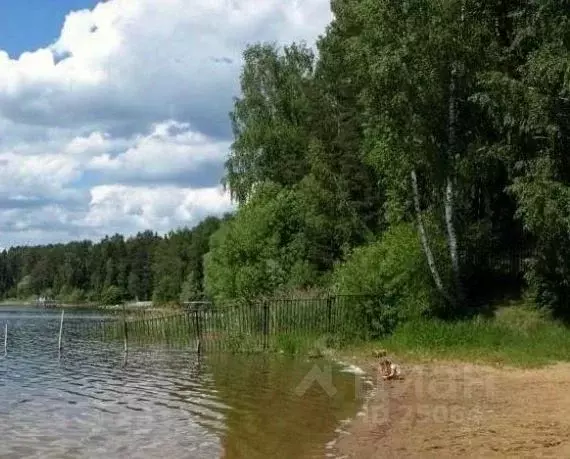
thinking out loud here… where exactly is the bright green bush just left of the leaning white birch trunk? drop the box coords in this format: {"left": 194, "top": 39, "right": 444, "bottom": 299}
{"left": 333, "top": 224, "right": 441, "bottom": 337}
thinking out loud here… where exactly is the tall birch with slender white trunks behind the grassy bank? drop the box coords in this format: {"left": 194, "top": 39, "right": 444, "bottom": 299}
{"left": 336, "top": 0, "right": 502, "bottom": 310}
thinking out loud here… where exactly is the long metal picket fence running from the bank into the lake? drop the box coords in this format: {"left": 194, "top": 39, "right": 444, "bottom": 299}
{"left": 87, "top": 295, "right": 366, "bottom": 352}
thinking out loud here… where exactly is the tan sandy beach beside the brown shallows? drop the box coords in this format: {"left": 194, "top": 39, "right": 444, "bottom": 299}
{"left": 327, "top": 356, "right": 570, "bottom": 459}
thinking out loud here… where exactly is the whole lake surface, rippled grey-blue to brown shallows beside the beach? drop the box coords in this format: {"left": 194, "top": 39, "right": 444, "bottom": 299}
{"left": 0, "top": 307, "right": 361, "bottom": 459}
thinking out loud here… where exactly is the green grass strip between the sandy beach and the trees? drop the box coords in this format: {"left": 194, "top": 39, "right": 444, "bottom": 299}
{"left": 342, "top": 304, "right": 570, "bottom": 367}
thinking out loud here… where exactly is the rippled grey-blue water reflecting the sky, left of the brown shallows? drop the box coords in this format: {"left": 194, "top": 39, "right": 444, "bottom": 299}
{"left": 0, "top": 312, "right": 226, "bottom": 458}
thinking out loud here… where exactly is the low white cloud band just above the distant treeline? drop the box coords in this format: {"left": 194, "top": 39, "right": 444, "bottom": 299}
{"left": 0, "top": 185, "right": 233, "bottom": 247}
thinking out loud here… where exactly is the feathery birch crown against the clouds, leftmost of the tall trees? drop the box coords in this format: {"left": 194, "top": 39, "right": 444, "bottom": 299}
{"left": 224, "top": 44, "right": 314, "bottom": 203}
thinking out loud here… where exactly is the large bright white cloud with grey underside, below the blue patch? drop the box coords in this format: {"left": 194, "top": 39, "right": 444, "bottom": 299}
{"left": 0, "top": 0, "right": 330, "bottom": 131}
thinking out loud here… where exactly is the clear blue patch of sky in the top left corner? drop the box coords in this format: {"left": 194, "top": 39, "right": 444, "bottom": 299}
{"left": 0, "top": 0, "right": 97, "bottom": 58}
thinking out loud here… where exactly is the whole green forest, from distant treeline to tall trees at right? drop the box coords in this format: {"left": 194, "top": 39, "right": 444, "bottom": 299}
{"left": 0, "top": 0, "right": 570, "bottom": 338}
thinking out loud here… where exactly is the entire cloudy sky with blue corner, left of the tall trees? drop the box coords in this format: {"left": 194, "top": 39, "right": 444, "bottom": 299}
{"left": 0, "top": 0, "right": 331, "bottom": 248}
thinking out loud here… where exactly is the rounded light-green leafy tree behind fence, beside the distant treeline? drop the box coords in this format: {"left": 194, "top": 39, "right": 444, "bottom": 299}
{"left": 205, "top": 182, "right": 324, "bottom": 299}
